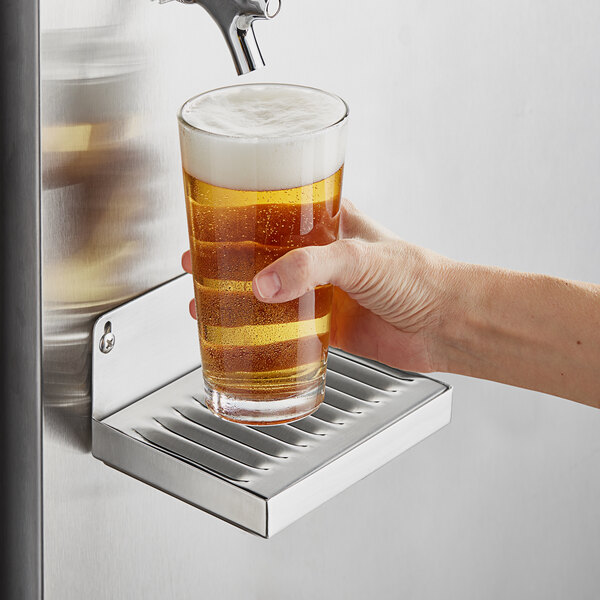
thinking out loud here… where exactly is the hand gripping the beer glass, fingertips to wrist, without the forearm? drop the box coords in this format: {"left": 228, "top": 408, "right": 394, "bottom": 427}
{"left": 182, "top": 200, "right": 453, "bottom": 372}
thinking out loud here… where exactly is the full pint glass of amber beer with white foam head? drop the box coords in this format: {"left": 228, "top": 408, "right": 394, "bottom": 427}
{"left": 178, "top": 84, "right": 348, "bottom": 425}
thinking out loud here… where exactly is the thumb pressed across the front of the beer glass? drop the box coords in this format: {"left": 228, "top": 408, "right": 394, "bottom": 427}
{"left": 252, "top": 239, "right": 368, "bottom": 303}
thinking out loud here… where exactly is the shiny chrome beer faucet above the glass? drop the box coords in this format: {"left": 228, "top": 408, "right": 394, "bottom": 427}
{"left": 159, "top": 0, "right": 281, "bottom": 75}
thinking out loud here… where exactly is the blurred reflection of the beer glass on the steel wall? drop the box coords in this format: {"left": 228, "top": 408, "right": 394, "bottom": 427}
{"left": 42, "top": 25, "right": 179, "bottom": 410}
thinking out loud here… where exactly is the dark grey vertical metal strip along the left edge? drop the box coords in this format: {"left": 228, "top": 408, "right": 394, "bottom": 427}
{"left": 0, "top": 0, "right": 42, "bottom": 600}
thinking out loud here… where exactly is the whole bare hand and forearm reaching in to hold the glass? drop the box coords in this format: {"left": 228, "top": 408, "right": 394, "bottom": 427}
{"left": 183, "top": 201, "right": 600, "bottom": 408}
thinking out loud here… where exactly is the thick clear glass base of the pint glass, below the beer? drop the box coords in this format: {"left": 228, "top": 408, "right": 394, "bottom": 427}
{"left": 204, "top": 377, "right": 325, "bottom": 425}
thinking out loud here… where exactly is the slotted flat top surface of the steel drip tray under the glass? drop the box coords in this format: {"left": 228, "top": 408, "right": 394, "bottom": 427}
{"left": 95, "top": 351, "right": 449, "bottom": 536}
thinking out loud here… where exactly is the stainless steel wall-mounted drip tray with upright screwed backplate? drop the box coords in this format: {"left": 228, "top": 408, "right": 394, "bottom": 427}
{"left": 93, "top": 276, "right": 451, "bottom": 537}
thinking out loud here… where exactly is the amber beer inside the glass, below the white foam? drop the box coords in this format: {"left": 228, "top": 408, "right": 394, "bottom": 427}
{"left": 184, "top": 168, "right": 343, "bottom": 412}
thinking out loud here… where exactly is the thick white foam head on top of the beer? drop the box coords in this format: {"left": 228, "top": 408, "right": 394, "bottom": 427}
{"left": 180, "top": 84, "right": 347, "bottom": 190}
